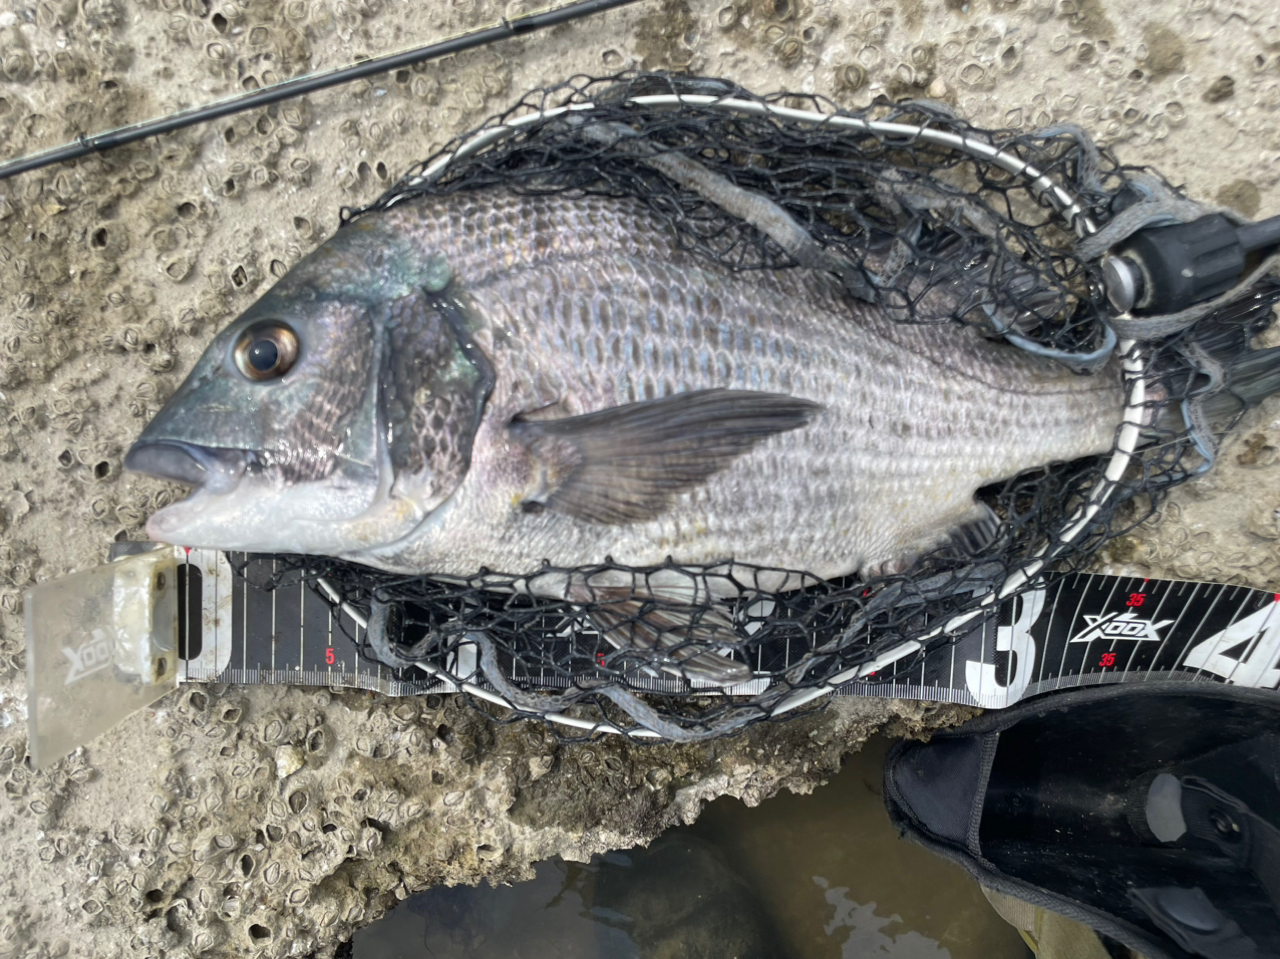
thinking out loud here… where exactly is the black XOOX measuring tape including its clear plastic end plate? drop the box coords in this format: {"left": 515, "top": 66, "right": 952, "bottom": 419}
{"left": 24, "top": 543, "right": 1280, "bottom": 768}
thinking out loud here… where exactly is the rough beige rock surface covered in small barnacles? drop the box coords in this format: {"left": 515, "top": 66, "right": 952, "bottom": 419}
{"left": 0, "top": 0, "right": 1280, "bottom": 959}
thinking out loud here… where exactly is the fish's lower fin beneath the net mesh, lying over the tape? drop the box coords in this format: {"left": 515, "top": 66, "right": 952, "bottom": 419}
{"left": 588, "top": 586, "right": 751, "bottom": 686}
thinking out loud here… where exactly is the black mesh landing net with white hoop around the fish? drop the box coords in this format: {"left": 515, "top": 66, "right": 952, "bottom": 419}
{"left": 220, "top": 74, "right": 1280, "bottom": 740}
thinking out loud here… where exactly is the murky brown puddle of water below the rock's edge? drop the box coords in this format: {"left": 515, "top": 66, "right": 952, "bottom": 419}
{"left": 353, "top": 739, "right": 1028, "bottom": 959}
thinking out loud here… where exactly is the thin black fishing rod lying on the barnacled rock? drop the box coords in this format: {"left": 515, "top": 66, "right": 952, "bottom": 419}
{"left": 0, "top": 0, "right": 639, "bottom": 179}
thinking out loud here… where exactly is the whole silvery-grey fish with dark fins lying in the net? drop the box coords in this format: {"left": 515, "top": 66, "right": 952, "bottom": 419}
{"left": 125, "top": 171, "right": 1280, "bottom": 684}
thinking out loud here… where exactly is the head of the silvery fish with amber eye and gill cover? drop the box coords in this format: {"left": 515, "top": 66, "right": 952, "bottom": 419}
{"left": 125, "top": 216, "right": 492, "bottom": 556}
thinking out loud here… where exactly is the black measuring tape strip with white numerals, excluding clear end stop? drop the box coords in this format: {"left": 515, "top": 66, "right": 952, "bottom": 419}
{"left": 167, "top": 549, "right": 1280, "bottom": 708}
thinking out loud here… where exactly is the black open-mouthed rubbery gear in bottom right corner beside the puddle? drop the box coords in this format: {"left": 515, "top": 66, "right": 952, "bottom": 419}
{"left": 884, "top": 682, "right": 1280, "bottom": 959}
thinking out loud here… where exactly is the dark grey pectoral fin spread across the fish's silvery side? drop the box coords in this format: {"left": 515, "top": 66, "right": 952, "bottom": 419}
{"left": 511, "top": 389, "right": 822, "bottom": 524}
